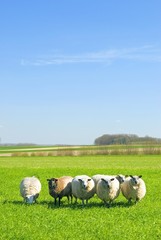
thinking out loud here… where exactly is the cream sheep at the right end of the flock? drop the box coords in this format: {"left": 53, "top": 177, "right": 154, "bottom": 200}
{"left": 121, "top": 175, "right": 146, "bottom": 203}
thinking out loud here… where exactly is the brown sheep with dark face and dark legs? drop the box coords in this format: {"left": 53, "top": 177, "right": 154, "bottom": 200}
{"left": 47, "top": 176, "right": 73, "bottom": 206}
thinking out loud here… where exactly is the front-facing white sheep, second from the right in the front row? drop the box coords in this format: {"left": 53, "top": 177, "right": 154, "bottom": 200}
{"left": 96, "top": 176, "right": 120, "bottom": 207}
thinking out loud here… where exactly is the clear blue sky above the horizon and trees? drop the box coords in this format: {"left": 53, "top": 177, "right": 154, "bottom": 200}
{"left": 0, "top": 0, "right": 161, "bottom": 145}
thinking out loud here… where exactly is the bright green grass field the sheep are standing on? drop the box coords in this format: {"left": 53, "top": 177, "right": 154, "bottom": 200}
{"left": 0, "top": 155, "right": 161, "bottom": 240}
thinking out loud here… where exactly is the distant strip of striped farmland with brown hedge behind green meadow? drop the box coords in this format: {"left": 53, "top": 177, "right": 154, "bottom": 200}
{"left": 0, "top": 144, "right": 161, "bottom": 157}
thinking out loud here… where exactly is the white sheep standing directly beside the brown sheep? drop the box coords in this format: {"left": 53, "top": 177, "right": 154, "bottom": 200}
{"left": 72, "top": 175, "right": 95, "bottom": 206}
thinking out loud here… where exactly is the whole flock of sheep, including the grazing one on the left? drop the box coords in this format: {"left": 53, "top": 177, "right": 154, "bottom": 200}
{"left": 20, "top": 174, "right": 146, "bottom": 206}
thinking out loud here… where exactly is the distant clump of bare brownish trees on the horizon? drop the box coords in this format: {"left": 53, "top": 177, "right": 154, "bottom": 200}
{"left": 94, "top": 134, "right": 161, "bottom": 145}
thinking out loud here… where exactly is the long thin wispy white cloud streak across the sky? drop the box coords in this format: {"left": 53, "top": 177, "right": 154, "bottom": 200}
{"left": 21, "top": 45, "right": 161, "bottom": 66}
